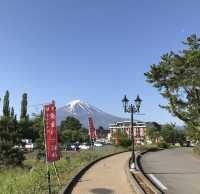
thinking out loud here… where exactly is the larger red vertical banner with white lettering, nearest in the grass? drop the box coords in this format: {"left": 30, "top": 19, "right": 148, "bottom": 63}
{"left": 44, "top": 103, "right": 60, "bottom": 162}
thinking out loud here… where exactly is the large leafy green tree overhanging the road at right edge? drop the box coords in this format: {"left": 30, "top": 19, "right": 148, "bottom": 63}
{"left": 145, "top": 34, "right": 200, "bottom": 136}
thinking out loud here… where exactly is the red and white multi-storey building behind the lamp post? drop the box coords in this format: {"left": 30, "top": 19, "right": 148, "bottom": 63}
{"left": 109, "top": 121, "right": 146, "bottom": 144}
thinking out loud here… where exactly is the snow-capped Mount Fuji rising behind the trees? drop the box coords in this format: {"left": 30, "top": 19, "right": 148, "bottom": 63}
{"left": 57, "top": 100, "right": 126, "bottom": 128}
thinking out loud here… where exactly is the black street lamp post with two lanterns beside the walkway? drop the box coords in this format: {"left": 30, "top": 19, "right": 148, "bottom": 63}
{"left": 122, "top": 95, "right": 142, "bottom": 168}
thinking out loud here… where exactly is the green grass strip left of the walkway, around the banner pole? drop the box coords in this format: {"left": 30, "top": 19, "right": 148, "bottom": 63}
{"left": 0, "top": 146, "right": 124, "bottom": 194}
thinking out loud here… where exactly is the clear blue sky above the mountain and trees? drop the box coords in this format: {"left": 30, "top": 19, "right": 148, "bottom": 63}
{"left": 0, "top": 0, "right": 200, "bottom": 123}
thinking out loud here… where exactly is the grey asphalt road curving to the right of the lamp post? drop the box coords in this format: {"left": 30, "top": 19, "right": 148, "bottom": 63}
{"left": 141, "top": 148, "right": 200, "bottom": 194}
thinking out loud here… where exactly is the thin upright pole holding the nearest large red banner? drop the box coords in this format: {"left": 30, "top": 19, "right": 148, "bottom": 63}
{"left": 43, "top": 105, "right": 51, "bottom": 194}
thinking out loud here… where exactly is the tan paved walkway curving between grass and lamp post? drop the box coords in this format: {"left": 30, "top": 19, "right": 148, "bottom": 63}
{"left": 72, "top": 153, "right": 133, "bottom": 194}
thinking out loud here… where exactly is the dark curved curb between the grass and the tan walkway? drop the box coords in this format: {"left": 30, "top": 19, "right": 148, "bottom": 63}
{"left": 59, "top": 151, "right": 129, "bottom": 194}
